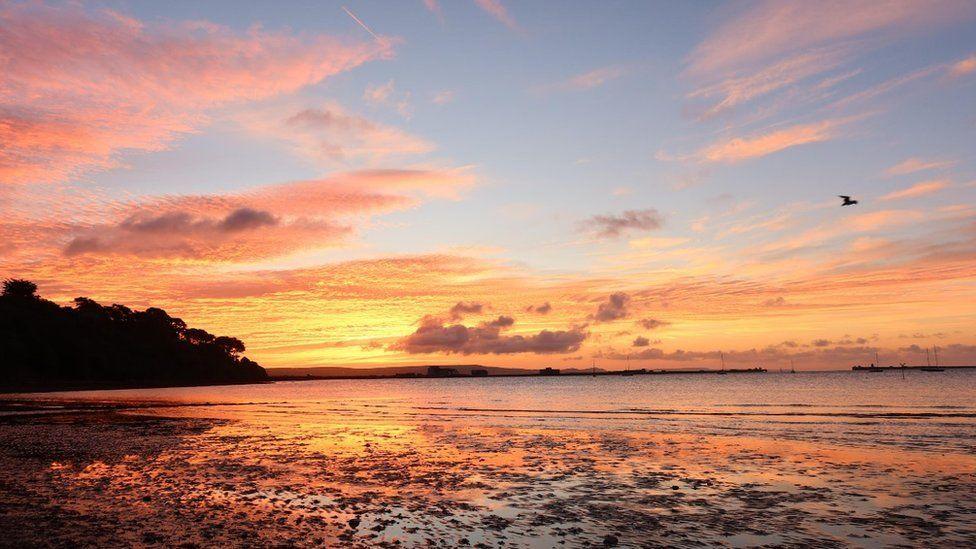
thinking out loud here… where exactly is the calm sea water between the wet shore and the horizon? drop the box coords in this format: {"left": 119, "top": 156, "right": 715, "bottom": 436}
{"left": 9, "top": 370, "right": 976, "bottom": 452}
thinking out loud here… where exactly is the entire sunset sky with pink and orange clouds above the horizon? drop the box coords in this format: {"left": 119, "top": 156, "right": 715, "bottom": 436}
{"left": 0, "top": 0, "right": 976, "bottom": 370}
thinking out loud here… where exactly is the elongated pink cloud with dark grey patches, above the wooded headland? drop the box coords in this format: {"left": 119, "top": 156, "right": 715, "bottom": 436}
{"left": 55, "top": 170, "right": 470, "bottom": 262}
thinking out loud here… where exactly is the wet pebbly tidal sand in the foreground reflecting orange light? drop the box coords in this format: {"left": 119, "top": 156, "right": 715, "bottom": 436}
{"left": 0, "top": 398, "right": 976, "bottom": 547}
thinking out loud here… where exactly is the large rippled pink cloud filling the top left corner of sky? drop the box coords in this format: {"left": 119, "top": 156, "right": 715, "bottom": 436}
{"left": 0, "top": 3, "right": 390, "bottom": 182}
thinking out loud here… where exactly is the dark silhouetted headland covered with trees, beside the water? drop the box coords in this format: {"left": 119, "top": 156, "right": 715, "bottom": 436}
{"left": 0, "top": 280, "right": 268, "bottom": 392}
